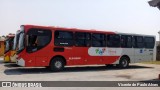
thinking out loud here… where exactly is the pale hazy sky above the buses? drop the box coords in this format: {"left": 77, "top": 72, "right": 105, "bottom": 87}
{"left": 0, "top": 0, "right": 160, "bottom": 40}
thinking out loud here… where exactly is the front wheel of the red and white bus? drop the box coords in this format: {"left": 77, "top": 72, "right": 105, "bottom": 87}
{"left": 50, "top": 57, "right": 64, "bottom": 72}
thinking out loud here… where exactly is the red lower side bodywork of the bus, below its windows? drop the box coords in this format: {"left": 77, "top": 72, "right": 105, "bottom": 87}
{"left": 17, "top": 47, "right": 120, "bottom": 67}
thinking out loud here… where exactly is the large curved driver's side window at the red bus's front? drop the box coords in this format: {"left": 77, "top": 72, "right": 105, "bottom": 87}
{"left": 27, "top": 28, "right": 52, "bottom": 53}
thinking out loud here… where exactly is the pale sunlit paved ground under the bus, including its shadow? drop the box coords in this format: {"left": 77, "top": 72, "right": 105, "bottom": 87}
{"left": 0, "top": 58, "right": 160, "bottom": 90}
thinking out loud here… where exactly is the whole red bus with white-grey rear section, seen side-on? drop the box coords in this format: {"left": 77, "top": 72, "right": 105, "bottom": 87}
{"left": 17, "top": 25, "right": 156, "bottom": 71}
